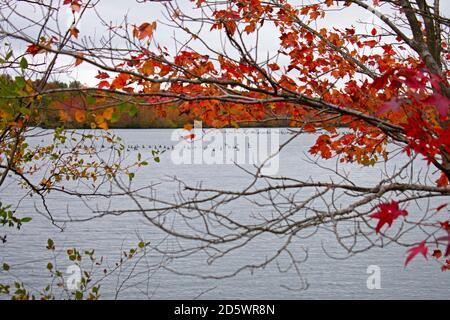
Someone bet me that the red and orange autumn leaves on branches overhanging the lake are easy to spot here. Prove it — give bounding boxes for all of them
[2,0,450,276]
